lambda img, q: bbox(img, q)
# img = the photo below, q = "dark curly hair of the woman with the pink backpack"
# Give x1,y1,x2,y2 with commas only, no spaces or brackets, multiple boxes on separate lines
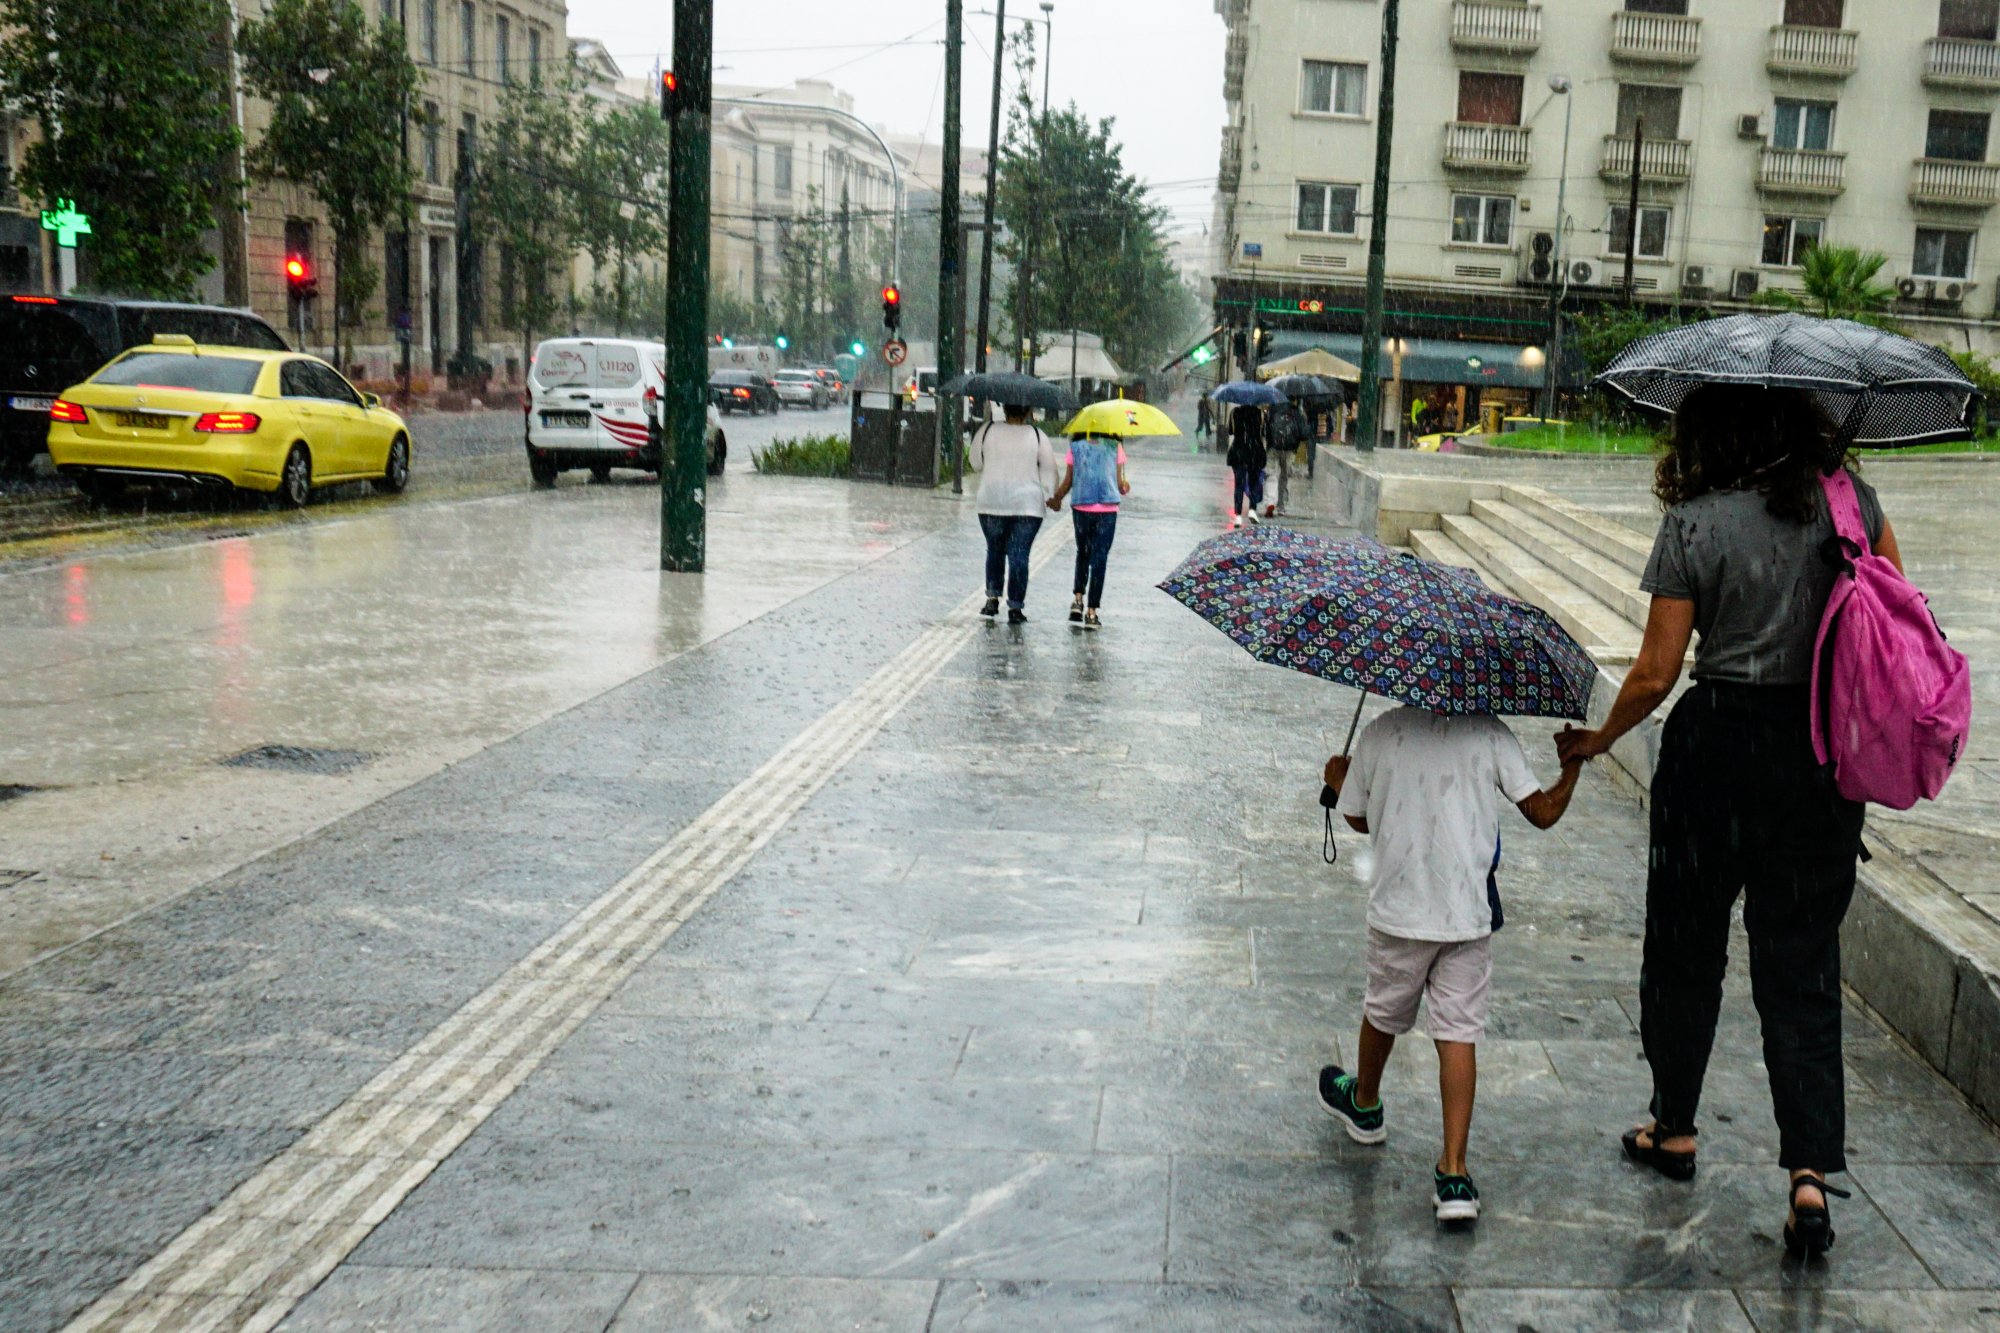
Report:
1652,384,1850,522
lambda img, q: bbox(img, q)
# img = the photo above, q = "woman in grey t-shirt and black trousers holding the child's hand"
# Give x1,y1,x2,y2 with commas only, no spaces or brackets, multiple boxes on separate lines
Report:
1558,384,1902,1255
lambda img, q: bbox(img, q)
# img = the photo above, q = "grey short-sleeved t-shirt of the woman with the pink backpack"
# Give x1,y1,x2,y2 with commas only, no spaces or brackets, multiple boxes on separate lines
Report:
1640,476,1882,685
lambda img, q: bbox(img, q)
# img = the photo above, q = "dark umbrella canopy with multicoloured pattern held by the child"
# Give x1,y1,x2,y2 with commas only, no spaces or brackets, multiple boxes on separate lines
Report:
1160,536,1596,719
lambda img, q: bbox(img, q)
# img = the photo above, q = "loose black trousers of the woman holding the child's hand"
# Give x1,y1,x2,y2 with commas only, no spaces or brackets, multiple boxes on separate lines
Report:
1638,685,1862,1171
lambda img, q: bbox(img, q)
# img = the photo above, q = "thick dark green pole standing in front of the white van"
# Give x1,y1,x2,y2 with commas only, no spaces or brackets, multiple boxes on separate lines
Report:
660,0,716,574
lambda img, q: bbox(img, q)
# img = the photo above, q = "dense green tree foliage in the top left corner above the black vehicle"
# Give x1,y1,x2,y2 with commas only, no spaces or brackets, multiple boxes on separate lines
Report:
0,0,242,298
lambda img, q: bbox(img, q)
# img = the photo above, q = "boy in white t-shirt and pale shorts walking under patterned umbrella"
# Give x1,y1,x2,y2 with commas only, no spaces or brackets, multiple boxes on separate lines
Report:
1320,707,1582,1223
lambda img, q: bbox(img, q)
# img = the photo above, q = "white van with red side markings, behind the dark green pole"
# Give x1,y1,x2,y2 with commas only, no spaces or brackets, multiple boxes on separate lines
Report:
526,338,728,486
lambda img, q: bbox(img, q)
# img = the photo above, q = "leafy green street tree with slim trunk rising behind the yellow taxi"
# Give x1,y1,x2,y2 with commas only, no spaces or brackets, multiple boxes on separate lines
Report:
238,0,418,364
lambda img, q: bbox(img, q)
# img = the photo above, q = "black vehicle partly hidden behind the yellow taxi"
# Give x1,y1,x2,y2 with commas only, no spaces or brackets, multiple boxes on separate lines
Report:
0,296,286,476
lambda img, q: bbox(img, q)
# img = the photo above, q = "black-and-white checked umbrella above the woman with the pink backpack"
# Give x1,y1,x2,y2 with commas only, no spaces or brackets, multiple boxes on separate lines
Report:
1592,314,1980,448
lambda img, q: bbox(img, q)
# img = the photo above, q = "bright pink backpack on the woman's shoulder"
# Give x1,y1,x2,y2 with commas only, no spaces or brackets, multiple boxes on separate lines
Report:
1812,468,1972,811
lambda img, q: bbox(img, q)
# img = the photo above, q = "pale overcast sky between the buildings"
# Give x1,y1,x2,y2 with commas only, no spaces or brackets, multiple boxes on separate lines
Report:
570,0,1224,226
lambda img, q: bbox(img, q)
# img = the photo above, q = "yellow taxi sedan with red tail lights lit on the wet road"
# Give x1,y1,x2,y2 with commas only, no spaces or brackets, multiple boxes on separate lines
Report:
48,334,410,508
